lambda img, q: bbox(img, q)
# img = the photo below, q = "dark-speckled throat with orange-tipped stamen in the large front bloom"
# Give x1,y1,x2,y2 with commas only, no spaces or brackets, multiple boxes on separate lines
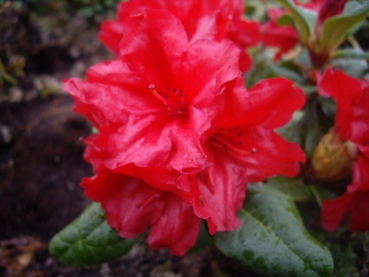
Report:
149,84,188,116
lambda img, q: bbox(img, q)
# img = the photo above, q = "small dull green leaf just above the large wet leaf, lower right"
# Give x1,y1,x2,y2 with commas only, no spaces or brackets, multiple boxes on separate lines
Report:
267,175,311,201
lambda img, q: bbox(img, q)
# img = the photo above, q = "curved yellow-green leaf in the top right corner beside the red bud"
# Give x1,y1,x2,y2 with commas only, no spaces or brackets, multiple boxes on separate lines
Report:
320,1,369,52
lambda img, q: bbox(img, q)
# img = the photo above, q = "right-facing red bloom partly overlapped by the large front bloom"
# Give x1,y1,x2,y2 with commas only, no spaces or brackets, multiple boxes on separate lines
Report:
102,75,305,234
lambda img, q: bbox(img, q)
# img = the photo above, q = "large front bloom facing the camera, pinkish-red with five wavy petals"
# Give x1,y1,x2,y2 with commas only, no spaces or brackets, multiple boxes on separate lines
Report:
64,10,240,171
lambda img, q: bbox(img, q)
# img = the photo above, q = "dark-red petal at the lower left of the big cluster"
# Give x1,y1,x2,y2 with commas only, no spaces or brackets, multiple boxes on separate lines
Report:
81,173,165,238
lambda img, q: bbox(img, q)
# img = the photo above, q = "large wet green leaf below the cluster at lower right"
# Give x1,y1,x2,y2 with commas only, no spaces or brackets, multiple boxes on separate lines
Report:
215,186,333,277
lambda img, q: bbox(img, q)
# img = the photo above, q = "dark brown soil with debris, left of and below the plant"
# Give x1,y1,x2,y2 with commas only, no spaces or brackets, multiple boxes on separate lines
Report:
0,0,369,277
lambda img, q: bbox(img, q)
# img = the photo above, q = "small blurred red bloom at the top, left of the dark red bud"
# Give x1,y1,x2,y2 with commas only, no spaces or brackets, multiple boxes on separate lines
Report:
261,8,299,60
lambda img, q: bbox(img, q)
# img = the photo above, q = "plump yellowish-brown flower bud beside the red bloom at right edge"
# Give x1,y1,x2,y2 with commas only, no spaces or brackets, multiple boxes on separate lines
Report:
311,129,358,181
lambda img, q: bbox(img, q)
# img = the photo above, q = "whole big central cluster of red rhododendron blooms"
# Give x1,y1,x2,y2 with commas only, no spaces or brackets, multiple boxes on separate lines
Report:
64,0,305,255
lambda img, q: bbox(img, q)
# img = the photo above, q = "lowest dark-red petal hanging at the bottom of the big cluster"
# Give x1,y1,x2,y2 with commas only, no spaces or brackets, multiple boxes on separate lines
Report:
148,193,200,256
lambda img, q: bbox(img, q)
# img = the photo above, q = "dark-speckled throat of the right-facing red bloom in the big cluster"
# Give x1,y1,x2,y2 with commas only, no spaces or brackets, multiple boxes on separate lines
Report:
210,126,257,156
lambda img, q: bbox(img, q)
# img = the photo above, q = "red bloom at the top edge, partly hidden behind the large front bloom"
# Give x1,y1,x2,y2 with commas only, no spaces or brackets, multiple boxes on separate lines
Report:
99,0,260,71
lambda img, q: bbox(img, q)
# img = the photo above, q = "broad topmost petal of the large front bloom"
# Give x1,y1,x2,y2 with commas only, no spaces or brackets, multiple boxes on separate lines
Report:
120,10,188,88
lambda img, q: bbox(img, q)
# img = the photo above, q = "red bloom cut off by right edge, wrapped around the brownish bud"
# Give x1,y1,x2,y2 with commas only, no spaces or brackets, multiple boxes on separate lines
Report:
318,69,369,231
